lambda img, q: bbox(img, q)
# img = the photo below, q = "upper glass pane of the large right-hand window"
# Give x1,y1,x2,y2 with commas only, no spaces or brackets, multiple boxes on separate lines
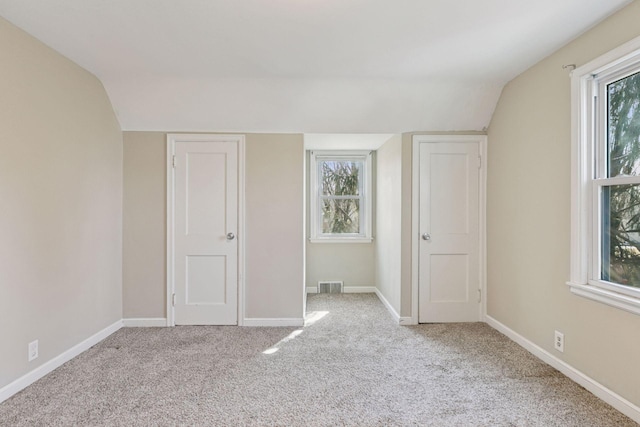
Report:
607,73,640,177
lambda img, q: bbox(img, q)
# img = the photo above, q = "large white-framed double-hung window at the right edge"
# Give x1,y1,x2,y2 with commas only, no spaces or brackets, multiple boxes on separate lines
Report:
569,38,640,314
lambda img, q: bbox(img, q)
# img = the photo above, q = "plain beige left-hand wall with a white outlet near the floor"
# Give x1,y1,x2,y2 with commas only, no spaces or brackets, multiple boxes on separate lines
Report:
0,18,122,388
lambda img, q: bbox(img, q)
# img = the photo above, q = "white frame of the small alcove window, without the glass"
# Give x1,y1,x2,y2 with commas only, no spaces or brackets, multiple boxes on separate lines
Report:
309,150,373,243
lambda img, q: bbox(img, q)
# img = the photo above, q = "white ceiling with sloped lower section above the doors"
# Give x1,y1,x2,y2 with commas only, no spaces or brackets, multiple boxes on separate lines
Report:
0,0,631,133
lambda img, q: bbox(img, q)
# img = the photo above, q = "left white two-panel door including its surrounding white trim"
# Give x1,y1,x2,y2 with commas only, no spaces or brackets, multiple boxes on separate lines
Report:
169,135,238,325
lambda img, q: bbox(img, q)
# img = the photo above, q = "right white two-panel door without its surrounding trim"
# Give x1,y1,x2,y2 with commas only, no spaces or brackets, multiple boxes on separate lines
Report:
418,142,480,323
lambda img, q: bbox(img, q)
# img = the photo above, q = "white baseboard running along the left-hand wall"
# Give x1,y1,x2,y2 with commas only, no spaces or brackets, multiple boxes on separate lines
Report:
0,320,122,403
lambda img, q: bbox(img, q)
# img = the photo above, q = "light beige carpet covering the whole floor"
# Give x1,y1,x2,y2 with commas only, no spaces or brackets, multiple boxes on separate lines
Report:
0,294,636,427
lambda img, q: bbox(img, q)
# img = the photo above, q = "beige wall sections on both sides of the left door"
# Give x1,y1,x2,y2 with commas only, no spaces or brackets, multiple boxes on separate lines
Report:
123,132,304,319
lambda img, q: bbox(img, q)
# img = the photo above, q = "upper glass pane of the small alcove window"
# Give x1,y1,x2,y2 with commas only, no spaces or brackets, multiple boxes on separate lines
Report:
319,160,363,196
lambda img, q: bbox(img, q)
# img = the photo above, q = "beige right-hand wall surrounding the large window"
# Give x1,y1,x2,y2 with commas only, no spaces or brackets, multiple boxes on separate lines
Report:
487,2,640,405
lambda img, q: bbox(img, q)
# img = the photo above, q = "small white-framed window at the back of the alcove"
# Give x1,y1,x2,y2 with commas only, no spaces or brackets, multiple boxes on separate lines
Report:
310,151,371,242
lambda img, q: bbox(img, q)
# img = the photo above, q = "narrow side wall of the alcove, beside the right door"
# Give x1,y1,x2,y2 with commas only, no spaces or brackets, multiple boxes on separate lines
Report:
375,135,402,313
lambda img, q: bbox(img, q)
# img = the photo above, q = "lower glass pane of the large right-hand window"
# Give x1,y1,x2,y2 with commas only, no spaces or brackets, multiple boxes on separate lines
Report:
601,184,640,287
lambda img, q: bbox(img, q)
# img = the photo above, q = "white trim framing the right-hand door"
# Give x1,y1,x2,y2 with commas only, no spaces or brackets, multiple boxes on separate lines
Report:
410,135,488,325
